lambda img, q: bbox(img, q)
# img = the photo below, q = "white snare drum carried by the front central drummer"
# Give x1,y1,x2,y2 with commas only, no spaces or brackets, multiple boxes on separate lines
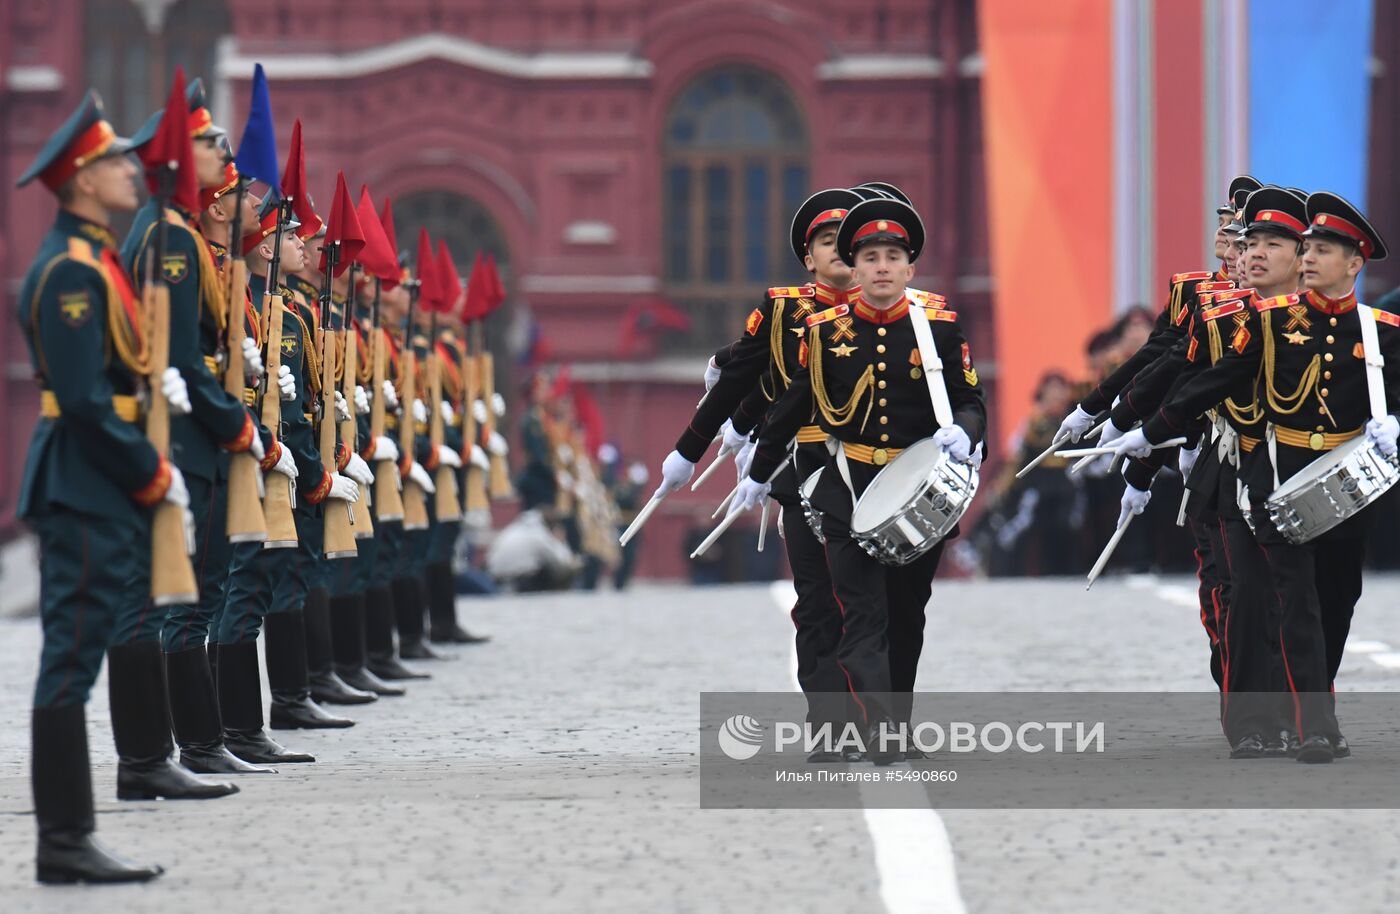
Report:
851,438,977,565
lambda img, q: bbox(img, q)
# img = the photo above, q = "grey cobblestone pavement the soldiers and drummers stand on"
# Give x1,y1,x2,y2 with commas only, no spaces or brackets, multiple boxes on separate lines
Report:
0,578,1400,914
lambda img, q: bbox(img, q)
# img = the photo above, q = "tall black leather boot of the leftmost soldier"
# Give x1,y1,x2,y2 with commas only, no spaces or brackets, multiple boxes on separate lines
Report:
29,704,165,885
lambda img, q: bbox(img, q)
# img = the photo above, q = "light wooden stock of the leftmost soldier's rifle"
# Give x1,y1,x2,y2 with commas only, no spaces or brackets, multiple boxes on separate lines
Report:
143,283,199,606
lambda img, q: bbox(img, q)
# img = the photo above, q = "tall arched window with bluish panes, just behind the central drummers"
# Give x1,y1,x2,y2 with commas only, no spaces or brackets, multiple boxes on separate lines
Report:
662,66,808,349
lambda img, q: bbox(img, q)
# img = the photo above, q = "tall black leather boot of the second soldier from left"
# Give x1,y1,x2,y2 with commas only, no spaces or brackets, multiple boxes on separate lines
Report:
106,641,238,799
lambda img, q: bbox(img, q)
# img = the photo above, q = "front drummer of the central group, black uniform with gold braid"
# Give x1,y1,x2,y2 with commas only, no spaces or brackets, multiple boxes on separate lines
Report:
732,199,987,764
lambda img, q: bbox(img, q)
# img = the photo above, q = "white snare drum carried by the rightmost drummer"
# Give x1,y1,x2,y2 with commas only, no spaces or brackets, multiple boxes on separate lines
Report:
1266,435,1400,543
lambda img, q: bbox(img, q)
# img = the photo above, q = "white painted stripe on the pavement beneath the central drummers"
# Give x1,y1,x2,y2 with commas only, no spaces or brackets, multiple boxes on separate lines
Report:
769,581,966,914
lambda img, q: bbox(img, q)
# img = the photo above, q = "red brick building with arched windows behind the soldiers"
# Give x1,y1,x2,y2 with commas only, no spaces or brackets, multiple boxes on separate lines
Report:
0,0,994,575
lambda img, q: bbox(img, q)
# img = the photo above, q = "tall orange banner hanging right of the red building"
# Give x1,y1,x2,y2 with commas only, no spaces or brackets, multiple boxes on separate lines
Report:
977,0,1113,448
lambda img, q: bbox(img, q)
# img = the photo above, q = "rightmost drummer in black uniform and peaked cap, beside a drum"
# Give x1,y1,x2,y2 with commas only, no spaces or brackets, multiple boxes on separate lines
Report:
1116,193,1400,763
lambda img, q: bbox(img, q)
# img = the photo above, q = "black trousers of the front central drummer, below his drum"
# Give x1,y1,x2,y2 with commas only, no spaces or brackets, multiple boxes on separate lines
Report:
822,515,944,726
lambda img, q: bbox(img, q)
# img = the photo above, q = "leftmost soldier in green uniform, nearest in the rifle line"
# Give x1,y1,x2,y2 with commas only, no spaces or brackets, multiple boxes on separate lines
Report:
18,92,189,883
